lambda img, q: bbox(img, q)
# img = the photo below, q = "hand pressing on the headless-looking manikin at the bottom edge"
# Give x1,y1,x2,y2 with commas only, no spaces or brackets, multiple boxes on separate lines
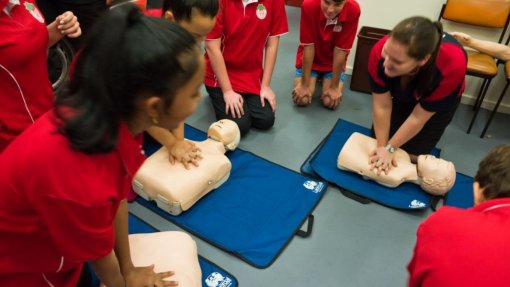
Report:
125,265,179,287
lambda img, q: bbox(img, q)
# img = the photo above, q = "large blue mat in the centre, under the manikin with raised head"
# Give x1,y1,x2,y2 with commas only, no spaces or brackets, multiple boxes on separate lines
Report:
137,126,327,268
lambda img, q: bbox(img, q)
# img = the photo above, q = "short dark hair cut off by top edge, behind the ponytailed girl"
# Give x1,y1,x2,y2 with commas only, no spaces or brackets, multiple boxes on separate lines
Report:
163,0,219,22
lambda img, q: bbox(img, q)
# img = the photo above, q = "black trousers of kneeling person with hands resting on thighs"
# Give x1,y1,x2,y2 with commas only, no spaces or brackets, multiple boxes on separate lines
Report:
205,86,275,135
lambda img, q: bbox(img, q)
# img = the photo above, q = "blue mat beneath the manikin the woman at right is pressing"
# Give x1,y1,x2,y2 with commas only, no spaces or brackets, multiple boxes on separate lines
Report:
302,119,439,210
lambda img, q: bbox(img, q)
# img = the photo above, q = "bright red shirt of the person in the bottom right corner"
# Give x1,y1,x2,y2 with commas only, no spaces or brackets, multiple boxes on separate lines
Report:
407,198,510,287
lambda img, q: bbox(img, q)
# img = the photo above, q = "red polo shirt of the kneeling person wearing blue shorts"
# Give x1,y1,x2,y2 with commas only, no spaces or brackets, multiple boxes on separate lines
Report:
296,0,361,72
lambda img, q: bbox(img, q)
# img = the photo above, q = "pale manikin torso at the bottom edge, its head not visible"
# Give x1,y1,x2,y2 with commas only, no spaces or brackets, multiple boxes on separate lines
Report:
101,231,202,287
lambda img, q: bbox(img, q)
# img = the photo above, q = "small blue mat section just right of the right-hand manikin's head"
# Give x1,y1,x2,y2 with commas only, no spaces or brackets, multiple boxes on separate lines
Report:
444,173,474,208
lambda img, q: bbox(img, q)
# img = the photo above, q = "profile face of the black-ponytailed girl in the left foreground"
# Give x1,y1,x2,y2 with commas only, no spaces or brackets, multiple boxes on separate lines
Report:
158,56,205,130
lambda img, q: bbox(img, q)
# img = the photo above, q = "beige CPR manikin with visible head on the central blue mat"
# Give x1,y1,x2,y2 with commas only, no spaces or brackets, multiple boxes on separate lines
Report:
133,119,241,215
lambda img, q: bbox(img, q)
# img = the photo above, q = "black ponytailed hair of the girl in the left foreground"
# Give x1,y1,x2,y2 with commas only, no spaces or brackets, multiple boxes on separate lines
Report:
55,4,199,153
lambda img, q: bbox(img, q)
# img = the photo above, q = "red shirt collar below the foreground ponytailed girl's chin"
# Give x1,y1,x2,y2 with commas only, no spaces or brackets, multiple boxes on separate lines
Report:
115,123,145,180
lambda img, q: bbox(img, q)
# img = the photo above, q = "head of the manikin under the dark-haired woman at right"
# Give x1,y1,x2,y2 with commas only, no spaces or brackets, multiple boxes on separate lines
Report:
417,155,456,195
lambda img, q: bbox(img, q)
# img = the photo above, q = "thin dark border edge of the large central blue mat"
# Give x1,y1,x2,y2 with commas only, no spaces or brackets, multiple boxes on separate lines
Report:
136,124,329,269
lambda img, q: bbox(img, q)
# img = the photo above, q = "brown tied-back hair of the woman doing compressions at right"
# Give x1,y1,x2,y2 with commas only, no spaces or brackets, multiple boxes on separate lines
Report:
390,16,443,98
